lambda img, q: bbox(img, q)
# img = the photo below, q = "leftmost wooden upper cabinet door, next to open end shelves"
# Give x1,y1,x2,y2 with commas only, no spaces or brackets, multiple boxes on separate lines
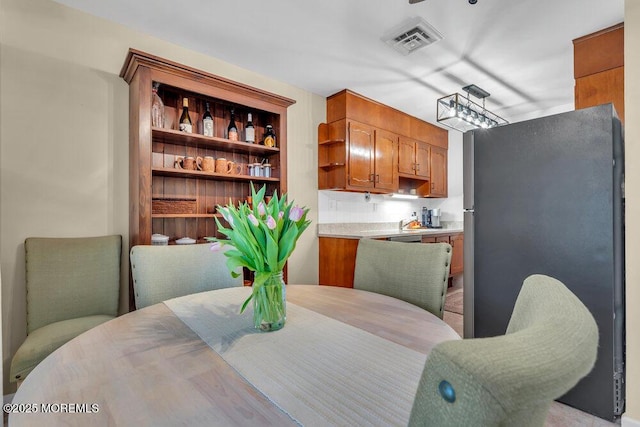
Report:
348,121,374,189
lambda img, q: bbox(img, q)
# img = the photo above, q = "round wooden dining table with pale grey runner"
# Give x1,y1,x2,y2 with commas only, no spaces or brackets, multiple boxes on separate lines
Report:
4,285,460,426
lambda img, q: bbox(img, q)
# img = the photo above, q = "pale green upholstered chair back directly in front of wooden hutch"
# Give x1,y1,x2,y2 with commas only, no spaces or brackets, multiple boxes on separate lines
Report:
130,244,243,309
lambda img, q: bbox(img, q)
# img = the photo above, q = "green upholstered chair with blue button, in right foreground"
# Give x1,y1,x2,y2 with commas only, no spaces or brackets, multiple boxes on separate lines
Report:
409,275,598,427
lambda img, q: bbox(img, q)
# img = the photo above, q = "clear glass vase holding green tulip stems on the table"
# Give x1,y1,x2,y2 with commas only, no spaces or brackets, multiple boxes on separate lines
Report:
253,271,287,332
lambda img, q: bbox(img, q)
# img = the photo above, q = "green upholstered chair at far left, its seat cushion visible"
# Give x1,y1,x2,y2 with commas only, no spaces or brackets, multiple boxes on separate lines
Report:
9,235,122,384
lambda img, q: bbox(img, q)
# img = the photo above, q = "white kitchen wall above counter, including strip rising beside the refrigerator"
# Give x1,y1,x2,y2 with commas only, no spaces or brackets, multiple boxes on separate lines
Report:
318,131,462,224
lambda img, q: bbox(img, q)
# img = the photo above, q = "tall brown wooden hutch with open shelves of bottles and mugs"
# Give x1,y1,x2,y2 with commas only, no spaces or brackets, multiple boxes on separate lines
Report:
120,49,295,308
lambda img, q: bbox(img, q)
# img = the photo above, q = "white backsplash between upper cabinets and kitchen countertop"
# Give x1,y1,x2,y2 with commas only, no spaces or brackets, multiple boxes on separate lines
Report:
318,190,463,223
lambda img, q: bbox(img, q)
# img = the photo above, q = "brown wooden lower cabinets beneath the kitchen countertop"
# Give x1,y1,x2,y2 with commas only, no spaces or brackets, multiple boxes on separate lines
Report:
319,233,464,288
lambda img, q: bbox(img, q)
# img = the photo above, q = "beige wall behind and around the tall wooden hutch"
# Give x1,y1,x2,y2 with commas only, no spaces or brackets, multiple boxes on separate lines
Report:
0,0,325,393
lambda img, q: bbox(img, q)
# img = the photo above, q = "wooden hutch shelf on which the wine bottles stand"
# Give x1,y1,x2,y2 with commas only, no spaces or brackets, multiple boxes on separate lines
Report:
151,127,280,157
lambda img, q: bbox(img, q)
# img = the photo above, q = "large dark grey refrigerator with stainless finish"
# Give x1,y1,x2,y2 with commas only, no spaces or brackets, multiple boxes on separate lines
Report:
463,104,625,420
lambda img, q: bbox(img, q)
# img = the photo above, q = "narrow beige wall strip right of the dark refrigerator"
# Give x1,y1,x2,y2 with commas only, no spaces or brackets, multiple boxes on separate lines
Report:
623,0,640,426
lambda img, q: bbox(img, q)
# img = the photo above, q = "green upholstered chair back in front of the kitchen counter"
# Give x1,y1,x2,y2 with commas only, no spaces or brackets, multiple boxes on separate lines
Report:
353,239,451,319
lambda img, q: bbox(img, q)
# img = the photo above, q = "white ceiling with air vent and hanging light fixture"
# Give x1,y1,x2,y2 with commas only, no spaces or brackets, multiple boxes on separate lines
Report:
52,0,624,127
